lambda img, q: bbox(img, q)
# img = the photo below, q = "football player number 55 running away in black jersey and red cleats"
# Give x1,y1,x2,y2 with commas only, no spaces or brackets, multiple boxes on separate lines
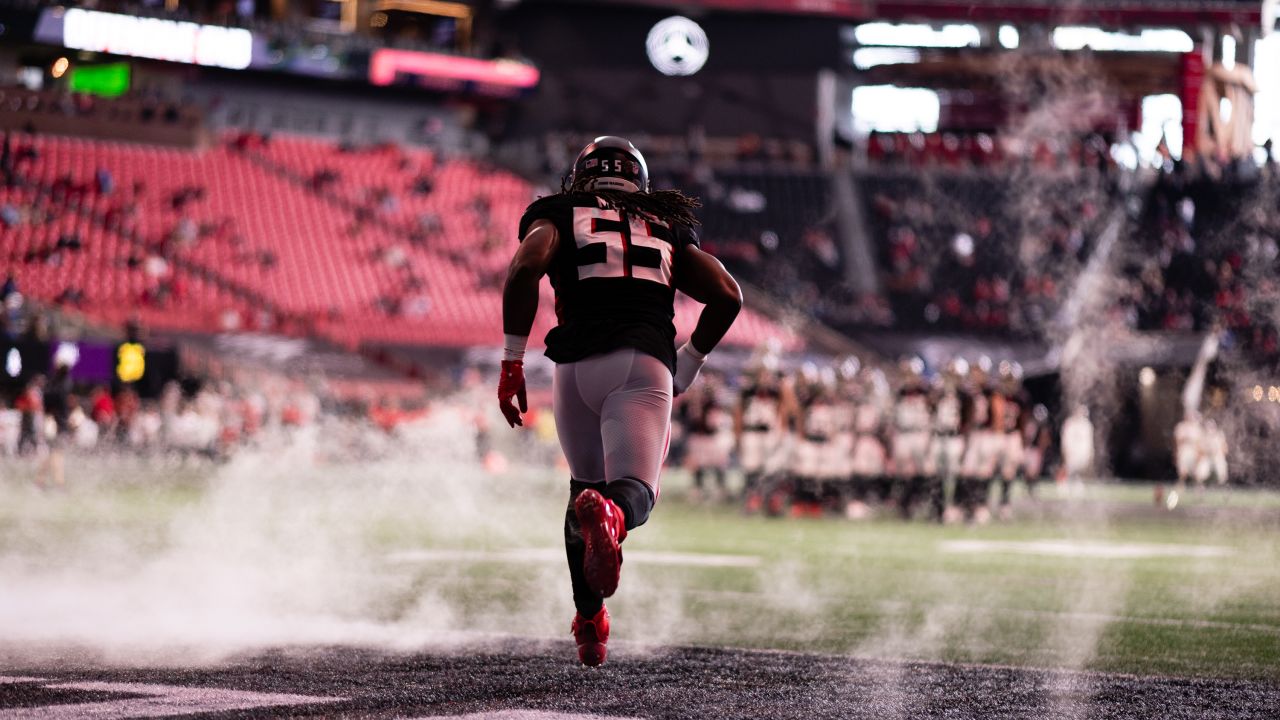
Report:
498,136,742,666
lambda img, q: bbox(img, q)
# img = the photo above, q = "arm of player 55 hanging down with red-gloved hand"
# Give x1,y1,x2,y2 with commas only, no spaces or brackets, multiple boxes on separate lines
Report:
498,215,559,428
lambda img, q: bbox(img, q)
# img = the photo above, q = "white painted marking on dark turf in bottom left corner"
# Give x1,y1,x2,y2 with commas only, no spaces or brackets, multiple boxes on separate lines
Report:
0,676,347,720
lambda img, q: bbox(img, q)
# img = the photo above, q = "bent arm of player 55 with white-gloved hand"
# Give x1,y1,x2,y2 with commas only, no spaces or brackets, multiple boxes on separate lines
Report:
672,243,742,395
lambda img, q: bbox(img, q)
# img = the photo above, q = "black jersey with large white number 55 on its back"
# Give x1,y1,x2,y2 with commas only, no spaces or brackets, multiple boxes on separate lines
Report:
520,192,698,373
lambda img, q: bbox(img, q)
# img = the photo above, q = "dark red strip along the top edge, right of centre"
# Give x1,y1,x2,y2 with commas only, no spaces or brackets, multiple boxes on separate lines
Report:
532,0,1262,28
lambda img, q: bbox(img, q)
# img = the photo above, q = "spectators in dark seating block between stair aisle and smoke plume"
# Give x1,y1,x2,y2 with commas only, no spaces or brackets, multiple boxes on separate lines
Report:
863,155,1115,337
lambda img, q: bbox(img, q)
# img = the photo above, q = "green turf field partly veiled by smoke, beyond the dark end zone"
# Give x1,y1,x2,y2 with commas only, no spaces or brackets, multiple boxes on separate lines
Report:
0,454,1280,680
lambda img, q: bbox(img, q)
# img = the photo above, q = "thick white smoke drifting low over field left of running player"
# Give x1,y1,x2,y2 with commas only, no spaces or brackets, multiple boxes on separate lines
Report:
0,413,570,664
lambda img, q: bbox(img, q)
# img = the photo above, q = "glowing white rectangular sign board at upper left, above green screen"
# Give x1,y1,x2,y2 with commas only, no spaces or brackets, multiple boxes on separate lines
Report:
63,8,253,70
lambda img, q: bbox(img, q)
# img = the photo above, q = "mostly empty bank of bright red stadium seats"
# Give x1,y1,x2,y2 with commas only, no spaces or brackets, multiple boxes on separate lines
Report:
5,133,799,347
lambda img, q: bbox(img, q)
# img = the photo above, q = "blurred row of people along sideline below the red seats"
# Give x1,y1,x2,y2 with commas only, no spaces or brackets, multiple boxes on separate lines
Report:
0,351,499,487
